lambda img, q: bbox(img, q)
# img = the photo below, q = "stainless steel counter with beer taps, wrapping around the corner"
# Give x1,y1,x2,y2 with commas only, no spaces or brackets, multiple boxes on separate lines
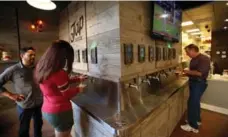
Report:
72,78,188,133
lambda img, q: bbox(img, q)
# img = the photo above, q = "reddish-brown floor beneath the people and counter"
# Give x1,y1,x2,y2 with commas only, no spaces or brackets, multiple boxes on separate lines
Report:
0,108,228,137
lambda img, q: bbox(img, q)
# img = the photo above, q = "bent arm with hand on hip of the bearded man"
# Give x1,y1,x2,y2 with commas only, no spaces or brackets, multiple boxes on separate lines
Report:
0,67,24,101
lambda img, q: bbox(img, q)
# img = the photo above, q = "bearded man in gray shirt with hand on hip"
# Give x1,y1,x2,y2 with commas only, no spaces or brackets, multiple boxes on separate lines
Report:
0,47,43,137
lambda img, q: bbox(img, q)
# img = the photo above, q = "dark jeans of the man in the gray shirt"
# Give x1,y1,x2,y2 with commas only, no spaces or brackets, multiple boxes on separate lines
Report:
17,106,43,137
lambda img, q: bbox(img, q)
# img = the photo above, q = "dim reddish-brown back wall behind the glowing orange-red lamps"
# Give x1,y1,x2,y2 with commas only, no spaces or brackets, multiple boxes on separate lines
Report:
19,3,59,59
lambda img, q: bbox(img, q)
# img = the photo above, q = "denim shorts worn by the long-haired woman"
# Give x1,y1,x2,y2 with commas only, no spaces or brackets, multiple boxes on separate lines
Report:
42,110,74,132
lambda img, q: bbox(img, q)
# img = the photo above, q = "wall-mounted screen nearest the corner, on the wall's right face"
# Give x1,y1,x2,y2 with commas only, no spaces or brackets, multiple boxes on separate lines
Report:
124,44,133,65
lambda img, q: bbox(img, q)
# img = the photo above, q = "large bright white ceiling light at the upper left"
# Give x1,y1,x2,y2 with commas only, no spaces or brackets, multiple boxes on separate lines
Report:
26,0,56,10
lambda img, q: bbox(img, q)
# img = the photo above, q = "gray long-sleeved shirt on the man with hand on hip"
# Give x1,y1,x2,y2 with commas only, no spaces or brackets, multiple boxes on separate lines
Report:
0,63,43,108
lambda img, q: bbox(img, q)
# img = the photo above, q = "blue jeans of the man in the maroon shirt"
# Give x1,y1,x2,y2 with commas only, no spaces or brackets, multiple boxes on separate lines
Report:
188,79,207,129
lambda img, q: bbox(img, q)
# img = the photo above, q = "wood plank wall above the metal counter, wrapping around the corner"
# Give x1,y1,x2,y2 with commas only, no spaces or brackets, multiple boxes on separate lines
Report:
59,1,181,81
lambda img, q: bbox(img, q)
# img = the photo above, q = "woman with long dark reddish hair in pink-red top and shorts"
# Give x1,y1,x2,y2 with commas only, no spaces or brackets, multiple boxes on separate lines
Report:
35,40,83,137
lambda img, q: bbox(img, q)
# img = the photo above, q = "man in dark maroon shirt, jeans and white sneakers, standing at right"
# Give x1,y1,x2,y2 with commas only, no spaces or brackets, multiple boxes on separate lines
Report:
181,44,210,133
